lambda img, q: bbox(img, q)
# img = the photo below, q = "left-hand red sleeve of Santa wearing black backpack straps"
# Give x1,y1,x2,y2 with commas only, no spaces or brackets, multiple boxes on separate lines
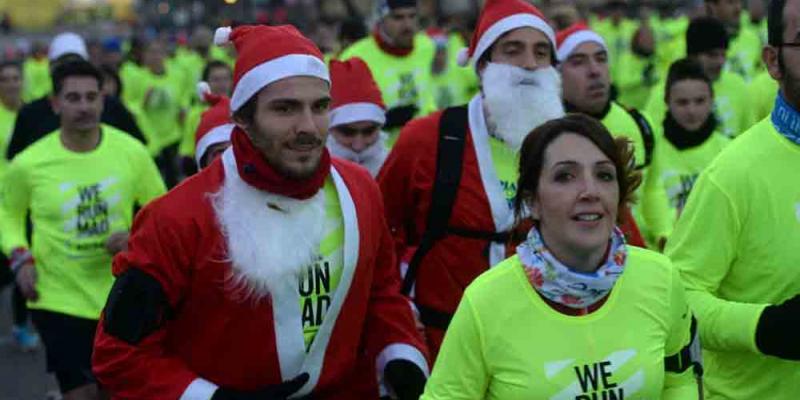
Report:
377,113,440,274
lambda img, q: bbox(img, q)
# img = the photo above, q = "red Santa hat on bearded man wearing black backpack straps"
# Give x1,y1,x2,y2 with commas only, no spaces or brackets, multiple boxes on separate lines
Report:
458,0,556,67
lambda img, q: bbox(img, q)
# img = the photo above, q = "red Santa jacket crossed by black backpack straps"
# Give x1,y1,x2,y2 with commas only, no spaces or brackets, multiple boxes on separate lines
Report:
378,96,528,357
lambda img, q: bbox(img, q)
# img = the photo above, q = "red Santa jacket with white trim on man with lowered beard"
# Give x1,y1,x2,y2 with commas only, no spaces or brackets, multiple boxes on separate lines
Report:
93,150,427,399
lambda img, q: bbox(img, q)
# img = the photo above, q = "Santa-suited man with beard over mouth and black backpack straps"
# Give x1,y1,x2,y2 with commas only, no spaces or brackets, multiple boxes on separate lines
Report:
378,0,564,355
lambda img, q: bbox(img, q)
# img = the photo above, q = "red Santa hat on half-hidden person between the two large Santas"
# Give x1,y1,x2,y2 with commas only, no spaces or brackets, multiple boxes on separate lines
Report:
329,57,386,128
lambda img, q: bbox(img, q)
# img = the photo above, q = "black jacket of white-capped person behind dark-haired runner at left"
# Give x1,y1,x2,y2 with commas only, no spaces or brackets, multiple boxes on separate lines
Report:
6,96,145,160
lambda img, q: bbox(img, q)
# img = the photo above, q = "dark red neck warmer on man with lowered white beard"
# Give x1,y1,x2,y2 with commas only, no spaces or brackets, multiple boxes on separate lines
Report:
231,127,331,200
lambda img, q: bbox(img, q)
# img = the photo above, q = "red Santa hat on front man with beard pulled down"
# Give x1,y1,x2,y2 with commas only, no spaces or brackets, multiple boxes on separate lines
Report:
214,25,330,112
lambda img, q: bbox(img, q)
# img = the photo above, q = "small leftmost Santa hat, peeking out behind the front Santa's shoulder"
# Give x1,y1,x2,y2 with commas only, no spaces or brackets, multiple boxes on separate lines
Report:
194,82,235,167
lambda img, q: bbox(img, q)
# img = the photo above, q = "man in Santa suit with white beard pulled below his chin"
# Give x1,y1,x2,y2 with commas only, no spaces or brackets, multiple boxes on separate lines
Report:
93,26,428,400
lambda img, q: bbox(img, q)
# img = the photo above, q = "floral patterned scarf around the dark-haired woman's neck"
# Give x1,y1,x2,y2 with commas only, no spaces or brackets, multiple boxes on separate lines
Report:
517,227,628,309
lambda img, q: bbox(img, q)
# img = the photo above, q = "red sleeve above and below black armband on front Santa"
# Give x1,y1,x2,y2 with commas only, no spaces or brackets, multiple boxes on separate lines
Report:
92,200,197,399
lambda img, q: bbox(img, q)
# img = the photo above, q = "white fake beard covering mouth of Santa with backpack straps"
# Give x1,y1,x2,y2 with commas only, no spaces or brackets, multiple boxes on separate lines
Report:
481,63,565,151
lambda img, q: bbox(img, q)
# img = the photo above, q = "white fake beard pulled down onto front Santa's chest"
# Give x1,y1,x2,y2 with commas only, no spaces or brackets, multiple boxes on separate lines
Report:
211,176,326,300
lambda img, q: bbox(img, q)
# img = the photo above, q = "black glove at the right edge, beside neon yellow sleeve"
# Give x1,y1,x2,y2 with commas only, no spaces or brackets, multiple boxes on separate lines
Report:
756,295,800,361
